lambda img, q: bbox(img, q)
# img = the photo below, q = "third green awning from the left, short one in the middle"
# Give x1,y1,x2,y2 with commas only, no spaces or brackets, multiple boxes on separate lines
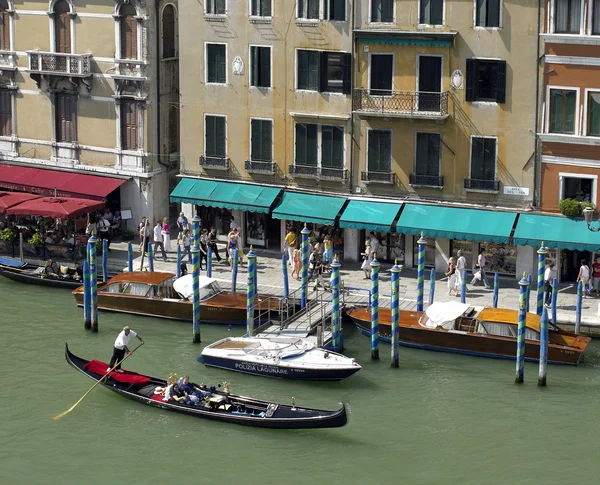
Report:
340,200,402,232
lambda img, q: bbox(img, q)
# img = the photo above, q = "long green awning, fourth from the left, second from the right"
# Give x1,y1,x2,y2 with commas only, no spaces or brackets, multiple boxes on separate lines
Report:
396,204,517,243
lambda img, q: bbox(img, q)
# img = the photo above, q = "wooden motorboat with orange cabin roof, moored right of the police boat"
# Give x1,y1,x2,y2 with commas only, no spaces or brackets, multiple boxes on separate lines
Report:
346,302,591,365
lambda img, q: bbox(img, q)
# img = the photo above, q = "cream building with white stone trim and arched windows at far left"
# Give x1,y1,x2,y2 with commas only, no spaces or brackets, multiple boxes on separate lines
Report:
0,0,179,229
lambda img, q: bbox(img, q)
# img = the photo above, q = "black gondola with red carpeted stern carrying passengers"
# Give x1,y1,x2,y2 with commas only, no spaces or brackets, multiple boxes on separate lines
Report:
65,344,348,429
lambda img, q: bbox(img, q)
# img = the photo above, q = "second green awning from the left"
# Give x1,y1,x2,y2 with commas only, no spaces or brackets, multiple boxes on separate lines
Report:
271,192,346,224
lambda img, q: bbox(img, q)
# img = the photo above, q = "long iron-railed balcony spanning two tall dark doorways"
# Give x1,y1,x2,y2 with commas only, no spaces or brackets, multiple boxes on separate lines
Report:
352,89,449,121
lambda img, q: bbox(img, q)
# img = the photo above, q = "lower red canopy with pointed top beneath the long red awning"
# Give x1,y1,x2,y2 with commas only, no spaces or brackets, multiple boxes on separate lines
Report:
6,197,104,219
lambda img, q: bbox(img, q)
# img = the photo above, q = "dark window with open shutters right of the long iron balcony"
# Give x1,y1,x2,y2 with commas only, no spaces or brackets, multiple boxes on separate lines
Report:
466,59,506,103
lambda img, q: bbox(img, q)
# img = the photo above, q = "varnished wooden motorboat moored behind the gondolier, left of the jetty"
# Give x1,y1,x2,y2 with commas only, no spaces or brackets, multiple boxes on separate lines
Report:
73,271,280,325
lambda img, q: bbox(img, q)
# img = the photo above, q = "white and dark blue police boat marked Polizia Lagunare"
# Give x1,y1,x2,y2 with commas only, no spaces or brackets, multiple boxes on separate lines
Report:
198,337,361,381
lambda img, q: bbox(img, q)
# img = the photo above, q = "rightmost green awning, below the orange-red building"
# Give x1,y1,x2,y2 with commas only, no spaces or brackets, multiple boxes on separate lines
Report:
513,214,600,251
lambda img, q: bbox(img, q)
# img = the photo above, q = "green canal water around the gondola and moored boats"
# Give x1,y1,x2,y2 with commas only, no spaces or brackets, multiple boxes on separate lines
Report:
0,280,600,485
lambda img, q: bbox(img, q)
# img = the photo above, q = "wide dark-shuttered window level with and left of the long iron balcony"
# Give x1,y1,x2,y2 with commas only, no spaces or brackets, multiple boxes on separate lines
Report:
297,50,351,94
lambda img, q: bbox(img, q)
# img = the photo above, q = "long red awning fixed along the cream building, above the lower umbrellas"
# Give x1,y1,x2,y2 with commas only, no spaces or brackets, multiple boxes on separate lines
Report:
0,163,127,200
